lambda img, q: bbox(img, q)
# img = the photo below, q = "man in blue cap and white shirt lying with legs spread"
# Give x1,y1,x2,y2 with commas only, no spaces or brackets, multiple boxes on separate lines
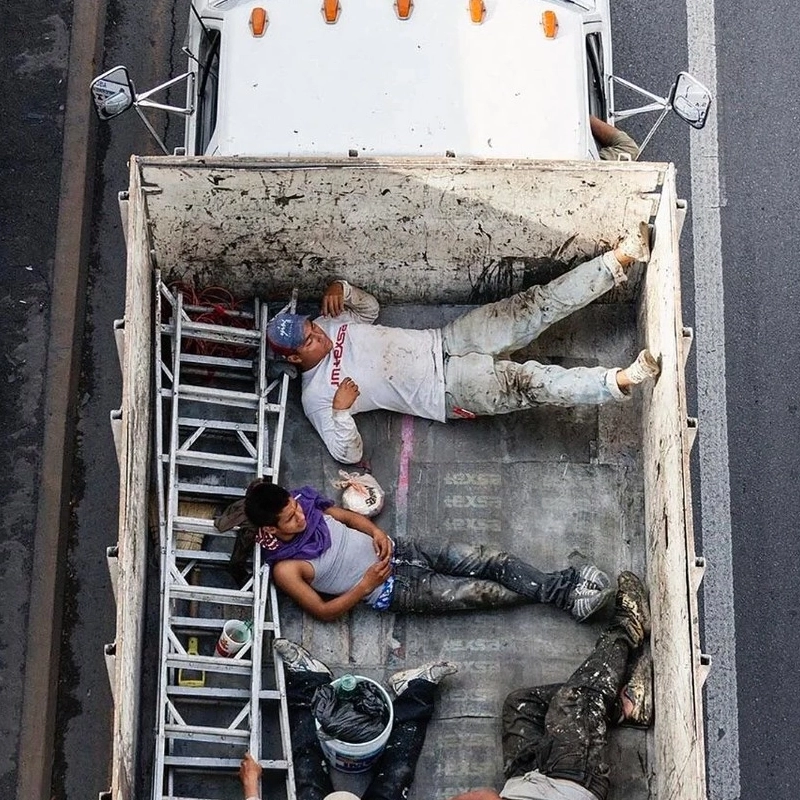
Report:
267,223,660,464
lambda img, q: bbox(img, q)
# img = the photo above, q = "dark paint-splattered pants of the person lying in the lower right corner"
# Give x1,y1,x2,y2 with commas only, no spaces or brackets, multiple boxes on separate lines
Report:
503,631,629,800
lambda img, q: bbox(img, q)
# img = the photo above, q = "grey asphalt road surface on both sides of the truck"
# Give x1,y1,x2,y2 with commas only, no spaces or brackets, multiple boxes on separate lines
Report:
0,0,800,800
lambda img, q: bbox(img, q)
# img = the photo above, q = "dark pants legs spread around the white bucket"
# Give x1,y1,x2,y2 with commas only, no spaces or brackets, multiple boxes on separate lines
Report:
286,670,436,800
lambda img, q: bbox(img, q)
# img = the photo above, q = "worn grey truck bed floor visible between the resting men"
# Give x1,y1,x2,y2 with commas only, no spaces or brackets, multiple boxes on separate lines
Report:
281,304,652,800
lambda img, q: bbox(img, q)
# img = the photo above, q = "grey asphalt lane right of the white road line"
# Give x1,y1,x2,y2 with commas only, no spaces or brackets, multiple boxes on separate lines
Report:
712,0,800,800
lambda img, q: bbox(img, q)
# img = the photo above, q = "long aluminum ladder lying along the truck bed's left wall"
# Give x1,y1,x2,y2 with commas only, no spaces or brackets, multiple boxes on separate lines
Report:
152,282,296,800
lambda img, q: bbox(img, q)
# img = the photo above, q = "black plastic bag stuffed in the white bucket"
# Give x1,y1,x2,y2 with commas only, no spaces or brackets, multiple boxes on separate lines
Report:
311,681,389,744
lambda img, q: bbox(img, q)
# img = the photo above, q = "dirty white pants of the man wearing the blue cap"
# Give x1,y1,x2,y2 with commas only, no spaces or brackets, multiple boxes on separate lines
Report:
442,253,627,418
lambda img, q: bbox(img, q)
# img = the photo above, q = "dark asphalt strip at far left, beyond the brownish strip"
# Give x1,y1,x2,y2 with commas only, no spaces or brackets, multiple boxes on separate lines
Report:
0,0,69,797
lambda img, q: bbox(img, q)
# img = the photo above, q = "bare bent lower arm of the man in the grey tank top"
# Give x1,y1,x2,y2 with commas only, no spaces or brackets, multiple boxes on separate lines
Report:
272,558,391,622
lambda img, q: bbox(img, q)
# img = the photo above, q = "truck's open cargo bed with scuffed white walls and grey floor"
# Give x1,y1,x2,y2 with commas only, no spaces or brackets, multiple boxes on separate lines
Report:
111,158,708,800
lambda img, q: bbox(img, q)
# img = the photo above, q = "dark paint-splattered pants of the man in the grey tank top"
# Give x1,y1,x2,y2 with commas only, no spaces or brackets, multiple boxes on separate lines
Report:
389,539,578,613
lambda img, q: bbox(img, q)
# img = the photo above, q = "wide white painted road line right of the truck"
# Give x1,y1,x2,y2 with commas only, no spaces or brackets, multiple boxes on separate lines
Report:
686,0,741,800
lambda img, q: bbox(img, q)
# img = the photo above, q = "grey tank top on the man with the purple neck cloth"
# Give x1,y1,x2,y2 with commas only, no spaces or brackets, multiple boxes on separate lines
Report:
307,514,383,603
